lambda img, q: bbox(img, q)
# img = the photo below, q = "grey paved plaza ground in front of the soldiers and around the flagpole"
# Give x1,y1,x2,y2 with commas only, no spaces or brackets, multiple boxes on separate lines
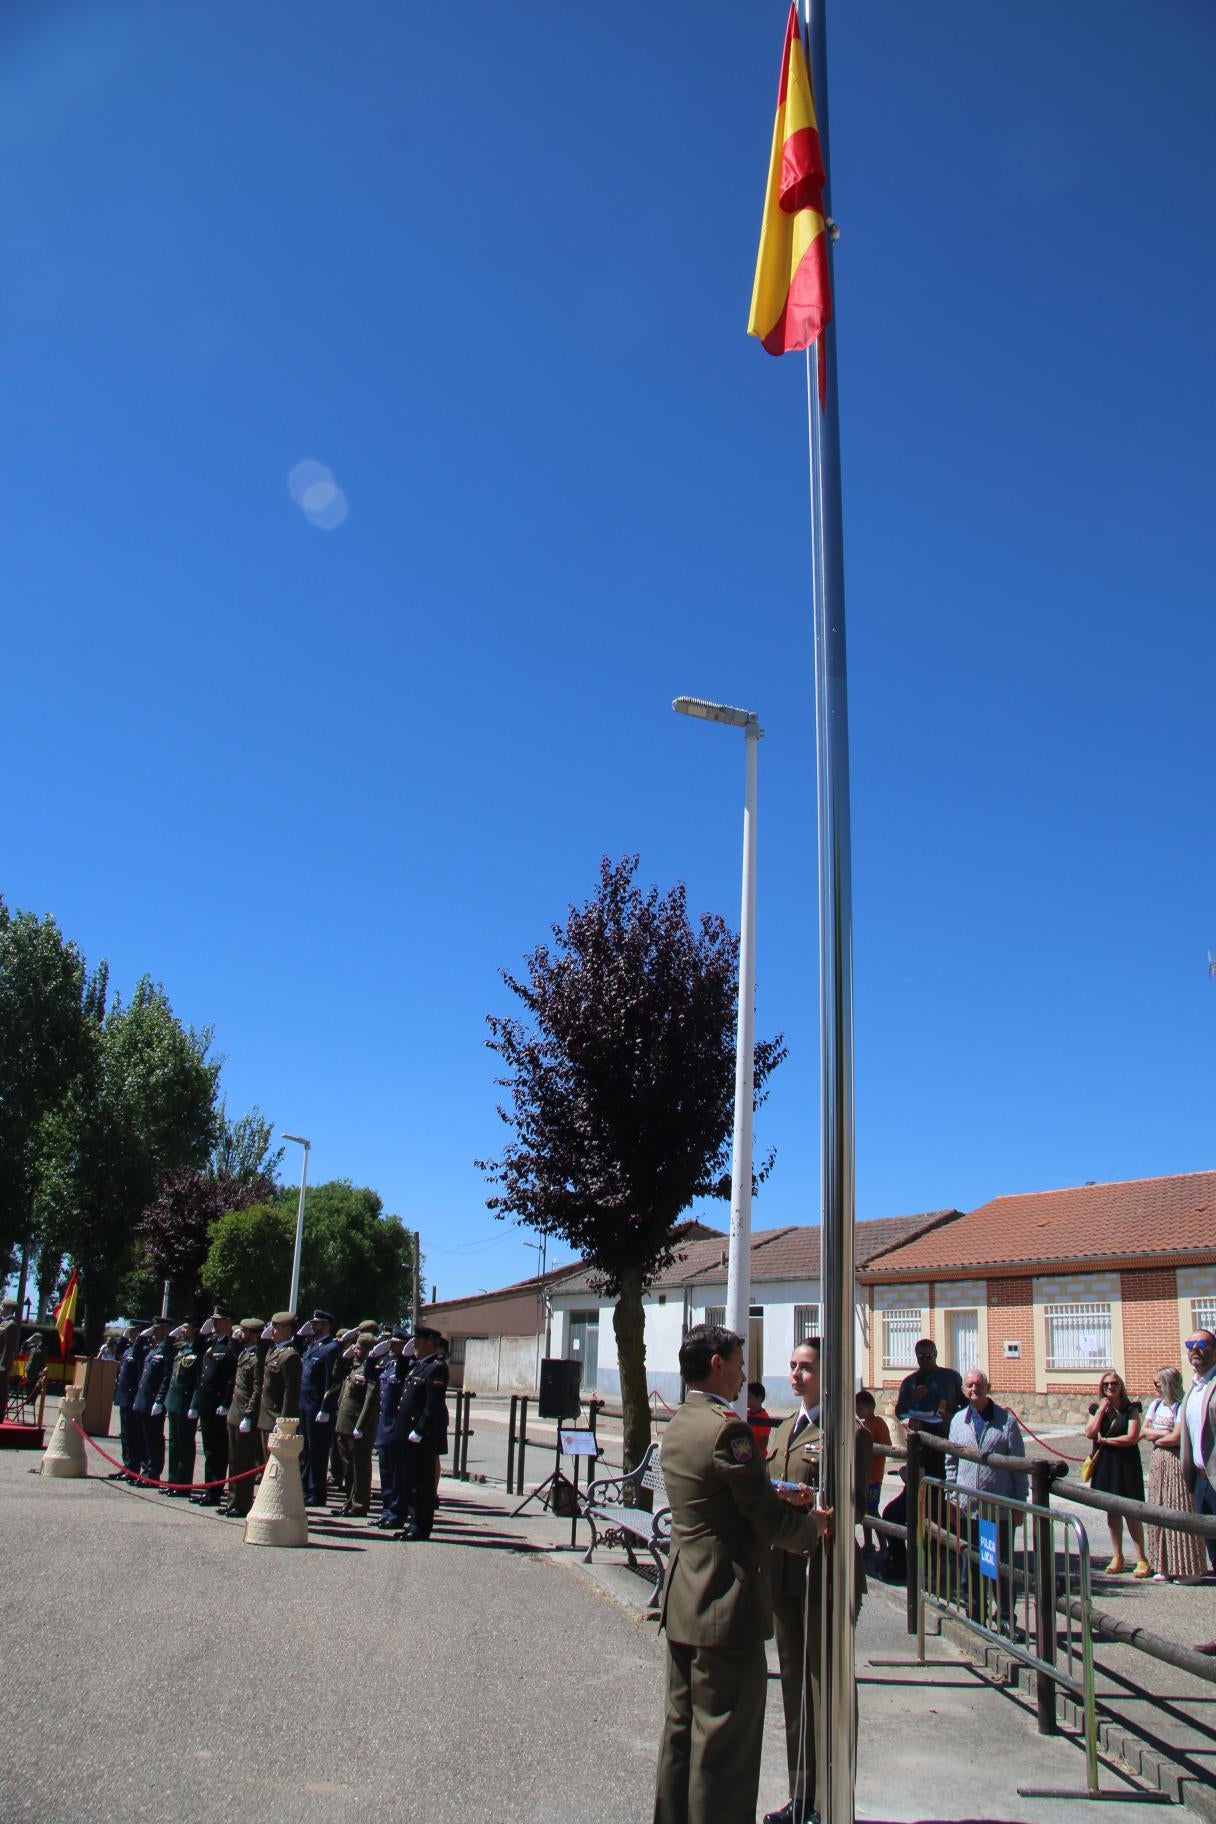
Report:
0,1430,1210,1824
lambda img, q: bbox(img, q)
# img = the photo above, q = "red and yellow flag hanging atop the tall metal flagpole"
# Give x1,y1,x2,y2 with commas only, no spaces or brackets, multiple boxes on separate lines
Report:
747,5,831,405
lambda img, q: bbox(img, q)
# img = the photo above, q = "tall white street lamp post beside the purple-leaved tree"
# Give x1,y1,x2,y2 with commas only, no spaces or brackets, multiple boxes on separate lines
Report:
671,697,764,1414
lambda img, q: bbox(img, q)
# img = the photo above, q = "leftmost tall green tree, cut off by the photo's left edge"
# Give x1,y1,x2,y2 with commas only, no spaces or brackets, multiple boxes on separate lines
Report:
0,897,106,1268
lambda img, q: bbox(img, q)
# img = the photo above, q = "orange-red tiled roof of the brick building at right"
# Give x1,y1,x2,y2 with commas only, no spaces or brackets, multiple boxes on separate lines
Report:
866,1171,1216,1279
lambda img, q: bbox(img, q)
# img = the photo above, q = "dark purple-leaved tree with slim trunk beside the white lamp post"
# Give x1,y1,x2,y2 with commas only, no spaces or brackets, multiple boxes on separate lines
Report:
478,855,786,1465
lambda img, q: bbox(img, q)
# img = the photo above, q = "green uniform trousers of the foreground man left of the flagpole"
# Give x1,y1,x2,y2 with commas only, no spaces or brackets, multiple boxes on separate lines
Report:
654,1640,768,1824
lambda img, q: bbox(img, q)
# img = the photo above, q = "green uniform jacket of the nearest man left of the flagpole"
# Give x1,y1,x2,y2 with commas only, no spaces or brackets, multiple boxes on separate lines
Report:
660,1392,817,1647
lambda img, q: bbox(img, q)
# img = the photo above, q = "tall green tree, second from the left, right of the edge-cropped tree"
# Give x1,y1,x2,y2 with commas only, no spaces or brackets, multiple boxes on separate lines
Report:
36,978,219,1348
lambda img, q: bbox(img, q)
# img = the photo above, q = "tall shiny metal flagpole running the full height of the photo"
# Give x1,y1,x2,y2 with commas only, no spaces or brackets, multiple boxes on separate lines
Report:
804,0,857,1824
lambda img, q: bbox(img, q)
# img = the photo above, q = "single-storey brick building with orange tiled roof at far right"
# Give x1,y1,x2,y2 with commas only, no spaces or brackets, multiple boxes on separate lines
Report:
857,1171,1216,1421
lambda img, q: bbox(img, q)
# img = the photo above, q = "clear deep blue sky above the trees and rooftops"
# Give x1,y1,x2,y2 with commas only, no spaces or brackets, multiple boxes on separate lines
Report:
0,0,1216,1297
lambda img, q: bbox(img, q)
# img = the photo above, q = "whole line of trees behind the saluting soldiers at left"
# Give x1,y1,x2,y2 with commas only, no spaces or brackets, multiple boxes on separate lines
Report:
0,897,414,1348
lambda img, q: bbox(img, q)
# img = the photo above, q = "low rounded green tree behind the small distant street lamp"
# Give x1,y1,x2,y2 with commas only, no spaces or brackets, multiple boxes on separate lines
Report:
202,1178,414,1322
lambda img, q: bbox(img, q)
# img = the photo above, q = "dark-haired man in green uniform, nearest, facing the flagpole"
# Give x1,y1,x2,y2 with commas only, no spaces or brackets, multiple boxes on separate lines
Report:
654,1324,831,1824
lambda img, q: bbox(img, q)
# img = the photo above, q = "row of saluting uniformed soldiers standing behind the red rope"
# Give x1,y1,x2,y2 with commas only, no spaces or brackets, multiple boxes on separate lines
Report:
115,1304,448,1539
